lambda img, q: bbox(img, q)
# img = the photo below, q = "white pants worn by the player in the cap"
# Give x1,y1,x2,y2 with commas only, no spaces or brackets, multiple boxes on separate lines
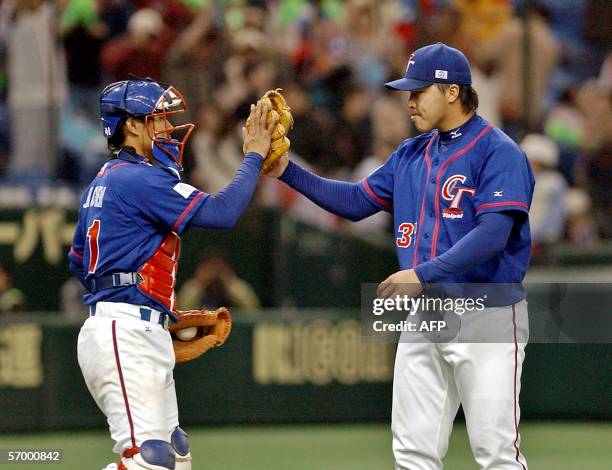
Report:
391,300,529,470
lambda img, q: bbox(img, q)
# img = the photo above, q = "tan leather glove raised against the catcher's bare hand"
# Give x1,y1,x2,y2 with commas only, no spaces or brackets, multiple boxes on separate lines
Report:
246,88,293,175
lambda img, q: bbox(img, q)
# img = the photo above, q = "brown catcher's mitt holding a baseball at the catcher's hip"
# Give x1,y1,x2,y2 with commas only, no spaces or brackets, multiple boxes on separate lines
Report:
168,307,232,362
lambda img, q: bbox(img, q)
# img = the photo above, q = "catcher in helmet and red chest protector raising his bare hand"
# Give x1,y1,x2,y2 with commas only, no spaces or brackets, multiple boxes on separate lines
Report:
68,77,274,470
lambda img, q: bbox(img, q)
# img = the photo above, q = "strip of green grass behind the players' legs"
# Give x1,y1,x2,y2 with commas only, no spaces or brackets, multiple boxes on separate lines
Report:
0,423,612,470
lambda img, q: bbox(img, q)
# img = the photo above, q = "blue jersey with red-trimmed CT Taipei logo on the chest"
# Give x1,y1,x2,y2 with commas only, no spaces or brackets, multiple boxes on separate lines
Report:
360,115,535,303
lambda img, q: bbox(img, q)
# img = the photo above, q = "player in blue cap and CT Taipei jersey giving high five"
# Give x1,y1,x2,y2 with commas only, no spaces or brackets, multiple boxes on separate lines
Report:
268,43,534,470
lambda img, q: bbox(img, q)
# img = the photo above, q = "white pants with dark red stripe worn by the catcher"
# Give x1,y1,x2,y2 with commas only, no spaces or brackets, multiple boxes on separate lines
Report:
78,302,179,454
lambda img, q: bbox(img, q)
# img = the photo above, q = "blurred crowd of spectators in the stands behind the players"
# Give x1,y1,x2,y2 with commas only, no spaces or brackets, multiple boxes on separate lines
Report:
0,0,612,258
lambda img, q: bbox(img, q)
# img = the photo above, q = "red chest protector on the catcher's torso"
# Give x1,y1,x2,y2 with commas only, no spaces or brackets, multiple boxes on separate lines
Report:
138,232,181,311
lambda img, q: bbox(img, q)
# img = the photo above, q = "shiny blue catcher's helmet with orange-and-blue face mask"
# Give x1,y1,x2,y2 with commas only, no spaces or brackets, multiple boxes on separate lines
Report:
100,77,194,166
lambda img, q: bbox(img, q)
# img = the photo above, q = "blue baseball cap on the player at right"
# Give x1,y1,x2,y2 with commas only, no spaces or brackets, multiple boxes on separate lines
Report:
385,42,472,91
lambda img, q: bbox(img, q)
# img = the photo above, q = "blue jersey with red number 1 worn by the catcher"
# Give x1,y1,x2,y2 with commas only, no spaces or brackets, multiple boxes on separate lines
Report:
68,150,209,313
